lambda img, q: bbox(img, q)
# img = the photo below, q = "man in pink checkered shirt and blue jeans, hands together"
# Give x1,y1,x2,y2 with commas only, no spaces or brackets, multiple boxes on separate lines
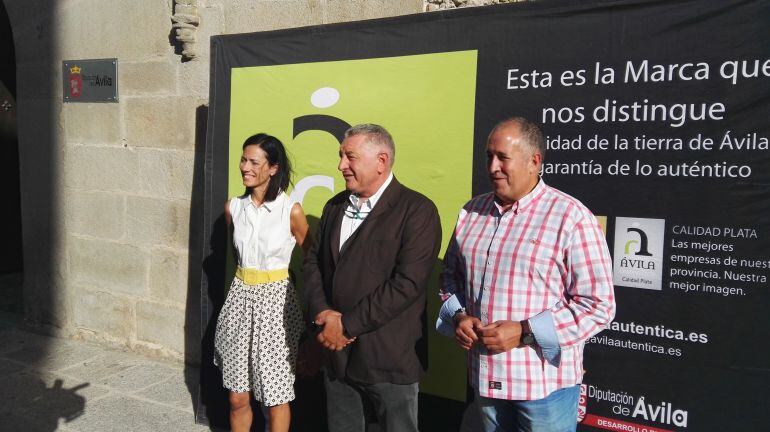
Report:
436,117,615,432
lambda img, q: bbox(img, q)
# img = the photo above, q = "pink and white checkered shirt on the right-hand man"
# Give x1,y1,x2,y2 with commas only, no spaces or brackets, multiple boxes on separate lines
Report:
441,180,615,400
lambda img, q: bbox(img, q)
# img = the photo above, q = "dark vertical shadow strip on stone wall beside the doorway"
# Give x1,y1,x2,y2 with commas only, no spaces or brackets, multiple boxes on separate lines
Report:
0,2,56,330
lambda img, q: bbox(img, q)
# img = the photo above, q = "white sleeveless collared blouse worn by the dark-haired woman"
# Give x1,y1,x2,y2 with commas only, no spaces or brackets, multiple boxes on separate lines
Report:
230,192,296,271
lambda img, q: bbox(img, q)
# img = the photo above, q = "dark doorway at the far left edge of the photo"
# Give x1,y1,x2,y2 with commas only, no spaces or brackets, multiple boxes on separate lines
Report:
0,2,24,313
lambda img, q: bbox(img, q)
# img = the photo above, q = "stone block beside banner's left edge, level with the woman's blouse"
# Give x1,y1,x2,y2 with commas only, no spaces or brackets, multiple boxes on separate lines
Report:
126,197,190,248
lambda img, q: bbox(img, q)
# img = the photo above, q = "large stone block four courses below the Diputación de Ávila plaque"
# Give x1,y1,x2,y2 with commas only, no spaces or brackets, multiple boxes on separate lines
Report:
69,237,147,296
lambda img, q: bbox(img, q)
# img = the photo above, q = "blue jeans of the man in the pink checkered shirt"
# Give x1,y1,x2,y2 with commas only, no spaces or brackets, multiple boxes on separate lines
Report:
476,385,580,432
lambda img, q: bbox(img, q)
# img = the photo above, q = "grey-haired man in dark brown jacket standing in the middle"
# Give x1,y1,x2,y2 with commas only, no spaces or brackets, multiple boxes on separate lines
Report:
304,124,441,432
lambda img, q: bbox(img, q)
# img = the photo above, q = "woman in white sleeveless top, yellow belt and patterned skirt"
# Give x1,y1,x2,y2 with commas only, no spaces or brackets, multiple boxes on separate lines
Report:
214,134,309,432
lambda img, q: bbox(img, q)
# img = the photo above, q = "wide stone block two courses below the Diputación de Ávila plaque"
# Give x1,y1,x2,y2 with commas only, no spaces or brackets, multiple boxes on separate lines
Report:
62,146,140,192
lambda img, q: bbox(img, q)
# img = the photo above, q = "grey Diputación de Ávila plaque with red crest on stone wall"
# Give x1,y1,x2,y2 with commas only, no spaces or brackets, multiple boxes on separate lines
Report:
62,58,118,102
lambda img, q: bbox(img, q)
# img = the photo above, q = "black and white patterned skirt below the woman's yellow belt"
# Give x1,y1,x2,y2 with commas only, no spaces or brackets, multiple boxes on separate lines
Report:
214,277,303,406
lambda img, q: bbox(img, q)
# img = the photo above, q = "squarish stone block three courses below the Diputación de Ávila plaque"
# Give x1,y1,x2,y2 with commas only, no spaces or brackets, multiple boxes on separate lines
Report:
64,189,126,240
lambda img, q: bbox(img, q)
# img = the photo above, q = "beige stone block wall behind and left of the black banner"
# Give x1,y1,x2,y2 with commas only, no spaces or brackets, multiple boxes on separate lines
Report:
3,0,425,362
